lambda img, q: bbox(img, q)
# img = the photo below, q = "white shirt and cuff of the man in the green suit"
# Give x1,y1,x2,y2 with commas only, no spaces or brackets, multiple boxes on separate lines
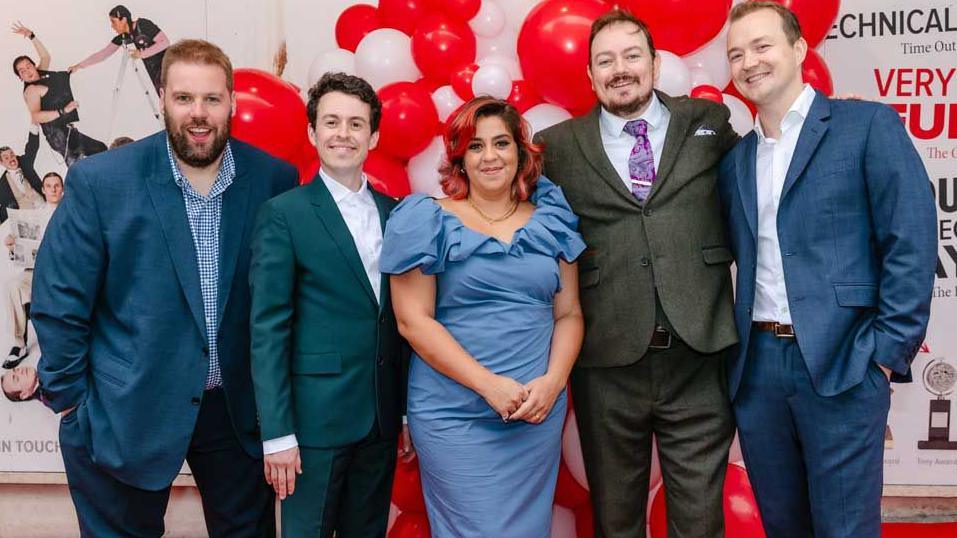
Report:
263,169,382,454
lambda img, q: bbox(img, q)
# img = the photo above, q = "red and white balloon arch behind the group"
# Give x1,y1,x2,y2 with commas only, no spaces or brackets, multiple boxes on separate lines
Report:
222,0,929,538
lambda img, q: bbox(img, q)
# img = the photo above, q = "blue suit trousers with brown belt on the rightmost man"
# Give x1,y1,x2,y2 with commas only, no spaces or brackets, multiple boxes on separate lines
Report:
734,331,890,538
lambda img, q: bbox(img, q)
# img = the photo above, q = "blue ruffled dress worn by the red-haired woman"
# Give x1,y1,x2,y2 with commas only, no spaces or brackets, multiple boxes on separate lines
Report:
379,177,585,538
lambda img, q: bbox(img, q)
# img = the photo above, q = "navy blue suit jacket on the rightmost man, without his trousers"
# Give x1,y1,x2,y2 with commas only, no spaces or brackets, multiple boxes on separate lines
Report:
718,93,937,398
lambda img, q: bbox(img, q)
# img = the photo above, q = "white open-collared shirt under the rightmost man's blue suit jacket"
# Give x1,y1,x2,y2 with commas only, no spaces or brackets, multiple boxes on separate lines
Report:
753,84,815,325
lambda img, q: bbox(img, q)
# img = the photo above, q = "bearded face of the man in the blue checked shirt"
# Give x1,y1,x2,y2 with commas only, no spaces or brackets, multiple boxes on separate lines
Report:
160,62,236,168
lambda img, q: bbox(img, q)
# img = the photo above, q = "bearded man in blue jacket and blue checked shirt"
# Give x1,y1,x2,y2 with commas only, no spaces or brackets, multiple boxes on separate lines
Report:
33,40,295,537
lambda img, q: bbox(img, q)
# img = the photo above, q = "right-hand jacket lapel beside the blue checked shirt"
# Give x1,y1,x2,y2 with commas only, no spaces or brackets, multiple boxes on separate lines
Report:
216,144,252,325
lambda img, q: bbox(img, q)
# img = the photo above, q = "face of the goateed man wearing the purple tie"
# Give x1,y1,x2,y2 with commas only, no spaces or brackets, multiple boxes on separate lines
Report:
588,22,661,118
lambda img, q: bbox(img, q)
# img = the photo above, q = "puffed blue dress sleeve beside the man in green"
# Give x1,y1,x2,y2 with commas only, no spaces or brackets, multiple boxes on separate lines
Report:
379,194,446,275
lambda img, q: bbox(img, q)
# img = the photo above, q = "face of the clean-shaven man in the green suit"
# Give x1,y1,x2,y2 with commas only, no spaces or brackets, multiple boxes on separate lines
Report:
309,92,379,176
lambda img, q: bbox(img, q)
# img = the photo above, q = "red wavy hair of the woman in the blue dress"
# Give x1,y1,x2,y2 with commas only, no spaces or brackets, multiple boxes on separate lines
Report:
439,97,542,201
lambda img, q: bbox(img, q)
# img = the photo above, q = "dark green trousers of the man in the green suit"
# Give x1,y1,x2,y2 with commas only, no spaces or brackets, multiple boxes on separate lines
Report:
281,425,397,538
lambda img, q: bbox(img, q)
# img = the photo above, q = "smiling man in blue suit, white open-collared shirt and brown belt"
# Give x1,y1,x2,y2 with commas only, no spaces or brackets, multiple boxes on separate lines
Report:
719,2,937,538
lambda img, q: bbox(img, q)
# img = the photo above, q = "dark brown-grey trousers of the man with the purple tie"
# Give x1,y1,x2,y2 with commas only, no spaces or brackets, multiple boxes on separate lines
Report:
571,342,734,538
